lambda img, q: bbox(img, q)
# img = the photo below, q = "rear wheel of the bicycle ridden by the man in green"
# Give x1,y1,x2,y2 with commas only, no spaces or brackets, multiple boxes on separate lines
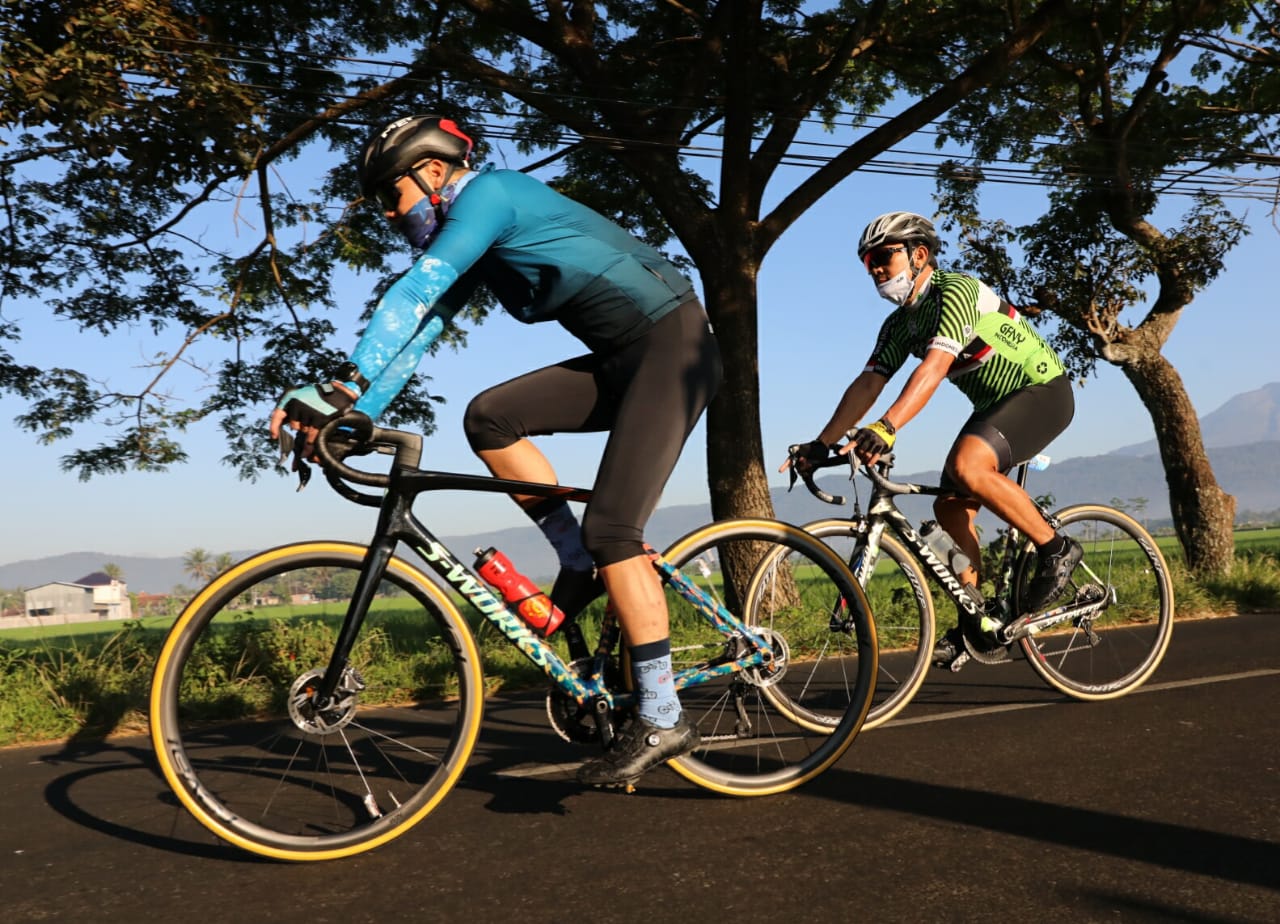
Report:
1014,504,1174,700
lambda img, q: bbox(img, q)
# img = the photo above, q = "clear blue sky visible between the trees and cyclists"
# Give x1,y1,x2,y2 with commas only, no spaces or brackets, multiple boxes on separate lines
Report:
0,149,1280,564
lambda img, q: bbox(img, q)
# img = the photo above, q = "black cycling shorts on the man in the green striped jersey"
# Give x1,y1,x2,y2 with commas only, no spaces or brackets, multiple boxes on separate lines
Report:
942,375,1075,488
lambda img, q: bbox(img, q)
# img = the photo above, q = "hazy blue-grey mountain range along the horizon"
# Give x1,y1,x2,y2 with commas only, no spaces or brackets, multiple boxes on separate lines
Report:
0,383,1280,593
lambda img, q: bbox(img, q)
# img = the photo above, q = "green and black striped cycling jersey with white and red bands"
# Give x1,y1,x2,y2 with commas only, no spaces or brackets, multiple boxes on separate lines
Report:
867,270,1065,411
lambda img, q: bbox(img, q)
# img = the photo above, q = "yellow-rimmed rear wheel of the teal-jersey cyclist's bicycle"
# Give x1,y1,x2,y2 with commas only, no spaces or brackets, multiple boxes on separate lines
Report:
664,520,876,796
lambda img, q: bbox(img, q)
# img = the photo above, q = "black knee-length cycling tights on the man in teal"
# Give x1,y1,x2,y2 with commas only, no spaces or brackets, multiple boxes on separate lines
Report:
463,301,722,566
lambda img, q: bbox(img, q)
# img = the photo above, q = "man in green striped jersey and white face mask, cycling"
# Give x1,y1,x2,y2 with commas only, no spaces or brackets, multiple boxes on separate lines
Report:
782,211,1082,660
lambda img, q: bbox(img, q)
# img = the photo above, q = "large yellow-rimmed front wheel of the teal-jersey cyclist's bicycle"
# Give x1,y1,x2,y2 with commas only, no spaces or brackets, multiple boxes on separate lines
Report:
151,541,484,860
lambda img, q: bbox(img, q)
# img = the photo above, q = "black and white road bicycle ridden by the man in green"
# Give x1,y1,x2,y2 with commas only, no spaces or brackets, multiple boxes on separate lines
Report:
791,447,1174,729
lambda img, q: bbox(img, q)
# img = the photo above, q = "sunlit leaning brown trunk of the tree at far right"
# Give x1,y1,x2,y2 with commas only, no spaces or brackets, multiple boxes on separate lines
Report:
1120,353,1235,575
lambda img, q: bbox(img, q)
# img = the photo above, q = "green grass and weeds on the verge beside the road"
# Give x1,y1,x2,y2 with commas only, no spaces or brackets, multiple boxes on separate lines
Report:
0,530,1280,745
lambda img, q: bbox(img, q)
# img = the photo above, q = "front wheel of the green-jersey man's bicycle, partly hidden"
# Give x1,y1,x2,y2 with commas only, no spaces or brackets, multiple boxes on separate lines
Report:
793,517,936,731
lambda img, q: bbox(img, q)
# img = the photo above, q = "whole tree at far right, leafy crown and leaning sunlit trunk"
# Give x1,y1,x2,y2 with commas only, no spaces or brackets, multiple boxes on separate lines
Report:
937,0,1280,573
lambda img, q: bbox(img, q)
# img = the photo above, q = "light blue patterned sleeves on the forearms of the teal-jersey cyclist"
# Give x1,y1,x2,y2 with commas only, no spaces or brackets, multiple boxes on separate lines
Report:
351,255,461,420
